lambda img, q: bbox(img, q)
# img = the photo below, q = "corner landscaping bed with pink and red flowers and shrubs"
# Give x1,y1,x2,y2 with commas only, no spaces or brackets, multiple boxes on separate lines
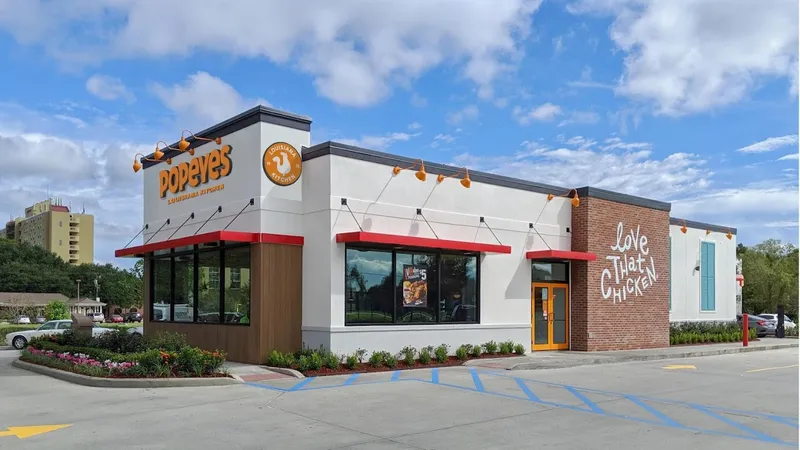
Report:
20,330,229,378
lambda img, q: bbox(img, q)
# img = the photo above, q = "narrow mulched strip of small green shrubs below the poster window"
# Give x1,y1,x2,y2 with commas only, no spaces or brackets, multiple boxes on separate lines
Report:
267,341,525,377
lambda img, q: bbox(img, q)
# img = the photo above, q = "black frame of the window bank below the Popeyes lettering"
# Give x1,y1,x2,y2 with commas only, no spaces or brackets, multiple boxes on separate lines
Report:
145,241,253,327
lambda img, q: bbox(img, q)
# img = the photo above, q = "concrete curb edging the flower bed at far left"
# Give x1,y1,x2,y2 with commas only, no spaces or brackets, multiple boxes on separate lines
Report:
11,359,242,388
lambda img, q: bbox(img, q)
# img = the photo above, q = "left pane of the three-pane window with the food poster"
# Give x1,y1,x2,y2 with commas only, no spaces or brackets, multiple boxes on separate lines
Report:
345,248,394,324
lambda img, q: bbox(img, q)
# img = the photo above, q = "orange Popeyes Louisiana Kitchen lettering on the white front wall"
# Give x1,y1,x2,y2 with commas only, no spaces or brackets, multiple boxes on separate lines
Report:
158,145,233,203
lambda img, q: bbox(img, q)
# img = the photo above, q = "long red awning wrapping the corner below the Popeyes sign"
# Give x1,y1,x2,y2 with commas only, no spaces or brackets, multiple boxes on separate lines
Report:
114,231,303,258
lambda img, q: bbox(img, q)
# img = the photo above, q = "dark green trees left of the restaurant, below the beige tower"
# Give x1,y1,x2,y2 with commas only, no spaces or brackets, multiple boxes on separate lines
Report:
0,238,143,308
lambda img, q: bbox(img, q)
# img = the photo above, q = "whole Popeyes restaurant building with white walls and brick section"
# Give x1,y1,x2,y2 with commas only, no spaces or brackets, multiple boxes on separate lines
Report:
116,106,737,363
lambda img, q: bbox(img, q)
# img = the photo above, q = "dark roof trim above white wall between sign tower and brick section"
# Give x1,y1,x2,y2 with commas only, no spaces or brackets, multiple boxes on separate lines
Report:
303,141,567,195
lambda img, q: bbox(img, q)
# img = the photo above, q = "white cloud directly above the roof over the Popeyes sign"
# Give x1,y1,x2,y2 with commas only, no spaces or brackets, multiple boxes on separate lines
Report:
152,72,269,126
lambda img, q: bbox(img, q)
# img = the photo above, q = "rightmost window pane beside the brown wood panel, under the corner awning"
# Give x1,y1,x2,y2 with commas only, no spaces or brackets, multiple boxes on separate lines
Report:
224,246,250,323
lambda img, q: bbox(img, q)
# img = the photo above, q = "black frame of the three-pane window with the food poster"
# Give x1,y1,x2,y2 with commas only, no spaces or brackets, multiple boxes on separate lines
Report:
343,244,482,327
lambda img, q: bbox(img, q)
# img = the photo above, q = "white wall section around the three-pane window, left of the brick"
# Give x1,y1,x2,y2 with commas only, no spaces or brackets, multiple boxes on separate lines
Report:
303,155,572,353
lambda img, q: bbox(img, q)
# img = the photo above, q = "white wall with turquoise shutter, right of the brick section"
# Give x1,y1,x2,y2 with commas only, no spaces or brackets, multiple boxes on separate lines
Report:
669,225,737,322
